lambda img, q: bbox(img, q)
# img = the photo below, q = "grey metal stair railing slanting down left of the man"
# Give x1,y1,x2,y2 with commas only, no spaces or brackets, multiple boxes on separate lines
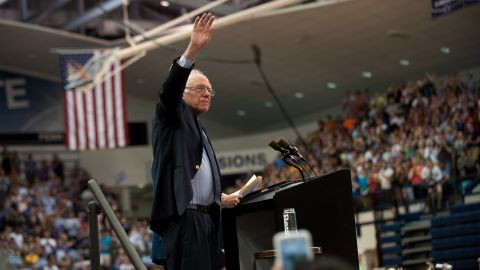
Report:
88,179,147,270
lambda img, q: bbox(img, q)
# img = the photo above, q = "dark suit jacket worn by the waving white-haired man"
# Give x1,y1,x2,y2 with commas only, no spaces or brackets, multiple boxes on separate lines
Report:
150,60,219,234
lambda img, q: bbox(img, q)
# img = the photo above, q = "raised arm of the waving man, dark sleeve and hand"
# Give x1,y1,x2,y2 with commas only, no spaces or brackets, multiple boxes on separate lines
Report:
160,13,215,111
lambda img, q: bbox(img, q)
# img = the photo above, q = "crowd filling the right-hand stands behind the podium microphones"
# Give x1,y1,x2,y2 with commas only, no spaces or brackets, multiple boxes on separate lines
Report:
263,73,480,215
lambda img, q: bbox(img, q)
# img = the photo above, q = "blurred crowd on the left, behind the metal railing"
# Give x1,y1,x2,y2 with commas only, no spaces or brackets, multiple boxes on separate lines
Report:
0,148,156,270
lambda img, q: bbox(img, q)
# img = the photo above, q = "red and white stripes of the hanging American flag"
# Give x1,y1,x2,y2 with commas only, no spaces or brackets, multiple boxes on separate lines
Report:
65,53,128,150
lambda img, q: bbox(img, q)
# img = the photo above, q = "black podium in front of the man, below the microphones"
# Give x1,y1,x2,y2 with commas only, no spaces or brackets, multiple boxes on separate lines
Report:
222,169,358,270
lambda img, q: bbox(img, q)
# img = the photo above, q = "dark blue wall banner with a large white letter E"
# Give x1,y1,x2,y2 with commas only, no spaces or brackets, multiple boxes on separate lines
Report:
0,71,64,134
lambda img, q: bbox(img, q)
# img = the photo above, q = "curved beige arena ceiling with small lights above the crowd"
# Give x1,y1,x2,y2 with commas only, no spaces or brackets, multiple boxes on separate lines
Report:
0,0,480,138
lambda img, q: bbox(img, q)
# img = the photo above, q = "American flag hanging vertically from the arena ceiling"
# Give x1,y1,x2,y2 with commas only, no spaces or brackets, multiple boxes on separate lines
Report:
60,51,129,150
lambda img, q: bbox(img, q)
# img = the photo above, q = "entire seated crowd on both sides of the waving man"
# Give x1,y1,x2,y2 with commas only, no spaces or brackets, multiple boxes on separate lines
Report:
0,70,480,270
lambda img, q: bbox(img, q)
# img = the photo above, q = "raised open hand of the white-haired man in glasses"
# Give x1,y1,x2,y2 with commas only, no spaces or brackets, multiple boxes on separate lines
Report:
184,13,215,59
